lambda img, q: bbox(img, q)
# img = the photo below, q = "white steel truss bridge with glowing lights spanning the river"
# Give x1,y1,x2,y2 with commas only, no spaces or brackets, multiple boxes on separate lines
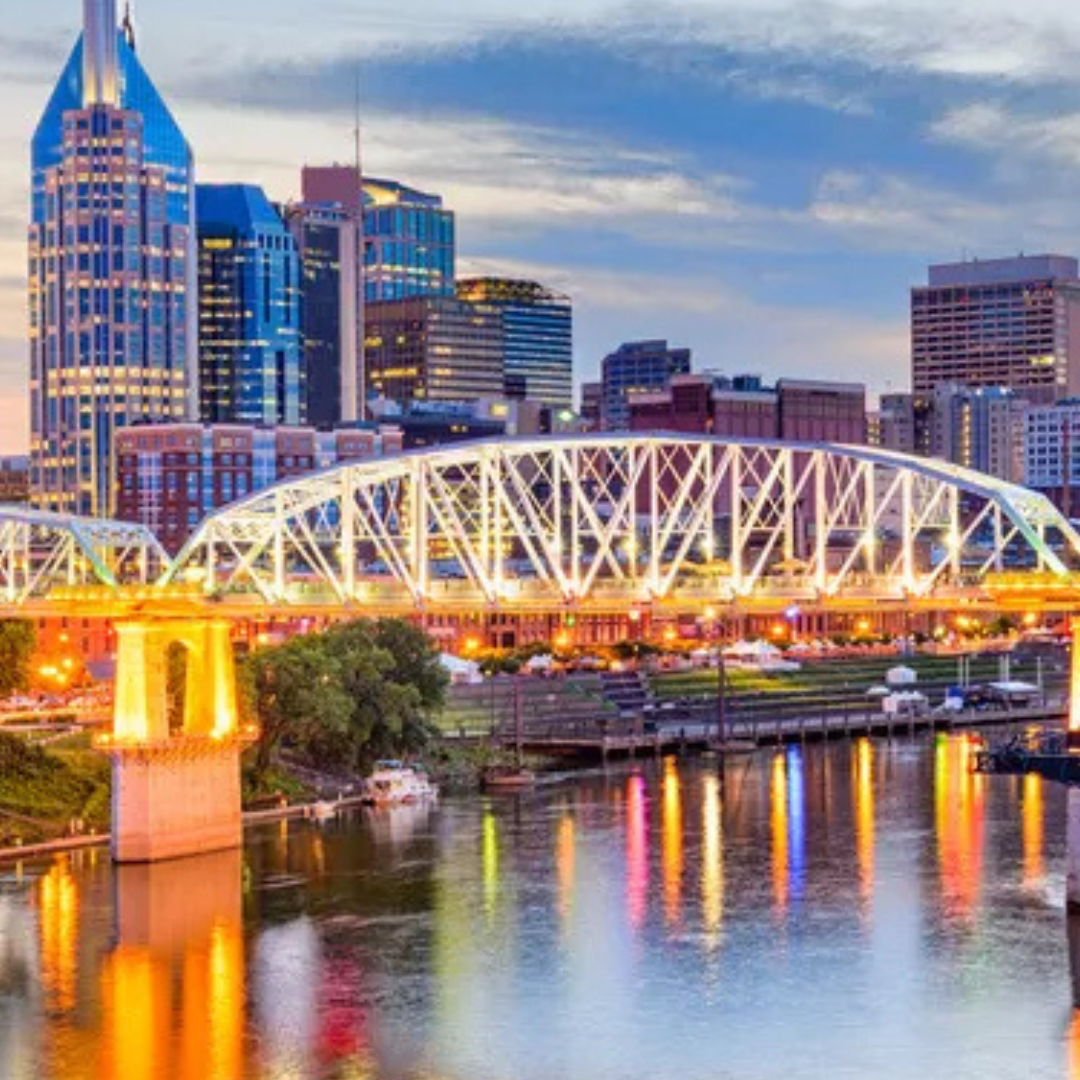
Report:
0,434,1080,615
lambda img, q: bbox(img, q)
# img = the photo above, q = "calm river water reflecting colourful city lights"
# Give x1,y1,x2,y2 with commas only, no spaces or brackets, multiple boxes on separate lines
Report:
0,737,1080,1080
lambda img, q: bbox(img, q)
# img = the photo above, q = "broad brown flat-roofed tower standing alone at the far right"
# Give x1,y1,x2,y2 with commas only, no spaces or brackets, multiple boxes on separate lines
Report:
912,255,1080,402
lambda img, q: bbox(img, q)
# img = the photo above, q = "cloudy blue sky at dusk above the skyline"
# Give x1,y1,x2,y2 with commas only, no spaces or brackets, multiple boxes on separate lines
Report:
0,0,1080,453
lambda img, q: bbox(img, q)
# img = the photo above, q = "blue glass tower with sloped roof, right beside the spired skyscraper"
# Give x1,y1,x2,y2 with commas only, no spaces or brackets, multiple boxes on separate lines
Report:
195,184,307,424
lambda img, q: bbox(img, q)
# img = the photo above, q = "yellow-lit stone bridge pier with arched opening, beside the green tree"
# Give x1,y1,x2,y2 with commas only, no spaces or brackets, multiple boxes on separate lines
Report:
98,618,253,863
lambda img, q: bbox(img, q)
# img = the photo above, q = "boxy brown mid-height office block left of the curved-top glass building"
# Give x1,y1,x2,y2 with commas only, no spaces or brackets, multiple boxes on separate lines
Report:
364,297,505,404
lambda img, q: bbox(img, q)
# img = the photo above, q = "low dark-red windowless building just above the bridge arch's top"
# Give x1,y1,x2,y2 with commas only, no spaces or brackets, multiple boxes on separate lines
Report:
629,375,866,444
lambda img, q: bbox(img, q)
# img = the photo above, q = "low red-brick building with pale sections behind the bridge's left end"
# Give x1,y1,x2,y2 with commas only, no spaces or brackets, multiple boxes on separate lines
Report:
117,423,402,553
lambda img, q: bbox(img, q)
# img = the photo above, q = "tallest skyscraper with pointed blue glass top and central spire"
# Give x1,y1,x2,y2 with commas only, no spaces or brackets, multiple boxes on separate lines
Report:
29,0,198,514
